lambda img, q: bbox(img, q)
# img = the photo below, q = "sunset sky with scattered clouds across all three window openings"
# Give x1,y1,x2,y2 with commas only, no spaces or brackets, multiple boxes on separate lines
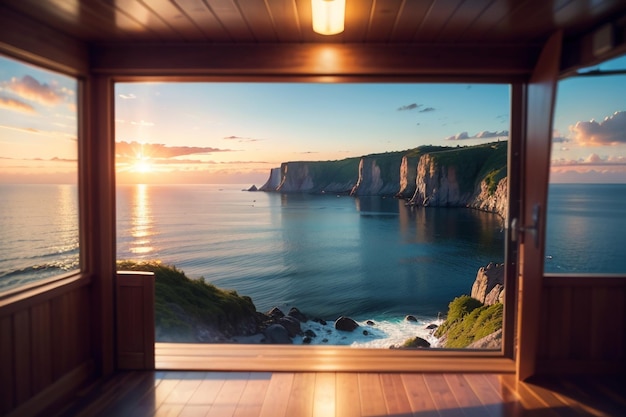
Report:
0,57,626,186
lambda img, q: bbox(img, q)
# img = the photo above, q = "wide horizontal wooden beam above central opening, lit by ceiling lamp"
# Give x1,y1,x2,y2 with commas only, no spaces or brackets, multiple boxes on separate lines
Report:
90,43,539,82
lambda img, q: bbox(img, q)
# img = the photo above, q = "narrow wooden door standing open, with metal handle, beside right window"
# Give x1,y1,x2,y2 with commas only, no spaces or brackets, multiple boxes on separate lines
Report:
517,32,563,380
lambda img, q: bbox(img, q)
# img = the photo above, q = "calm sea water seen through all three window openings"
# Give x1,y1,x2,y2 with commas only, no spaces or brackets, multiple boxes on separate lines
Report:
0,184,626,347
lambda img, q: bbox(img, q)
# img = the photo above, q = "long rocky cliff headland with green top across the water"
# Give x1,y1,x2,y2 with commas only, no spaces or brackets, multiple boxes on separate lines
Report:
260,142,507,218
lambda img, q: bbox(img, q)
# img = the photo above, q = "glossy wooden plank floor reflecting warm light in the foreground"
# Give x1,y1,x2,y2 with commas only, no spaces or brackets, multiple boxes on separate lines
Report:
53,371,626,417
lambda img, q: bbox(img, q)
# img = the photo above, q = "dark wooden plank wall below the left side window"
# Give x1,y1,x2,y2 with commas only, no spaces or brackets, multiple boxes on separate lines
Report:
0,277,94,416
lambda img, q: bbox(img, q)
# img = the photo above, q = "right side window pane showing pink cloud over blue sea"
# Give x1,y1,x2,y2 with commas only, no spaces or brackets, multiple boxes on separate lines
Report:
545,53,626,274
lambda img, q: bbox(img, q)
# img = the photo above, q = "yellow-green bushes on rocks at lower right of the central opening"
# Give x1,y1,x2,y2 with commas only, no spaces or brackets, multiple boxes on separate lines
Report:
435,295,503,348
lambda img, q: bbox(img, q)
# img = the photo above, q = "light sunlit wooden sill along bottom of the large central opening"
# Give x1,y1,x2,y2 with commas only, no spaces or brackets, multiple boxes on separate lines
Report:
155,343,515,373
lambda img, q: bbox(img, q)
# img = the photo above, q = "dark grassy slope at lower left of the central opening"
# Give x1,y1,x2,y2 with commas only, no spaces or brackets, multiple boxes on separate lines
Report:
117,261,256,341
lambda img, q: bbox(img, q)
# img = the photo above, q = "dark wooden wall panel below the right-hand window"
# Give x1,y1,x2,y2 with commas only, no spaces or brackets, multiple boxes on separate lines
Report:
537,276,626,374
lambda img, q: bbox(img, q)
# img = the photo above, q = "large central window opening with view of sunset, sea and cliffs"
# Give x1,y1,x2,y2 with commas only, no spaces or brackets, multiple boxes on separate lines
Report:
115,82,512,360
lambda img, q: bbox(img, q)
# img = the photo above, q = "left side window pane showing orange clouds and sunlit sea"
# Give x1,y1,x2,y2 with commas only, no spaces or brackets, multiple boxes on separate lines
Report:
0,56,79,291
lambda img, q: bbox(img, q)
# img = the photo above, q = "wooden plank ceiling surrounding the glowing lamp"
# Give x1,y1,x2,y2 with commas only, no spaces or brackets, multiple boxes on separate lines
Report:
2,0,626,45
